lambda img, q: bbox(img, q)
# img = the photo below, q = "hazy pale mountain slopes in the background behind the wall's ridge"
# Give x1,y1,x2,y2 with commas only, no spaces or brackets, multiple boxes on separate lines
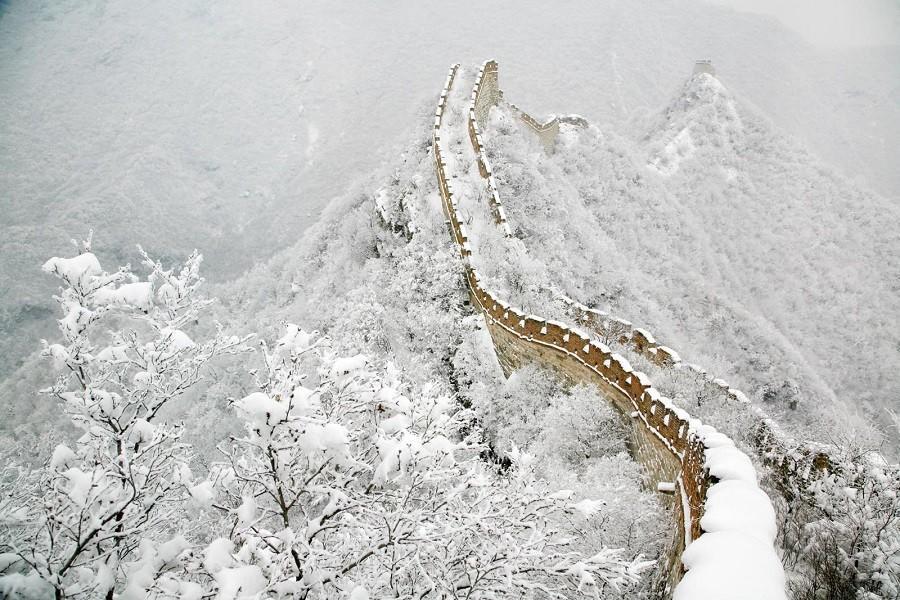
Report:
0,0,900,376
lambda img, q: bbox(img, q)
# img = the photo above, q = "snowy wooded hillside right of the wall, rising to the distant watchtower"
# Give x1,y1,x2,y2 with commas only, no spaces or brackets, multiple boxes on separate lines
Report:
484,74,900,448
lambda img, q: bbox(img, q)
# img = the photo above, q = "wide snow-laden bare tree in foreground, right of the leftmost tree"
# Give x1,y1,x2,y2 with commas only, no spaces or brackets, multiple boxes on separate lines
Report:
203,327,652,600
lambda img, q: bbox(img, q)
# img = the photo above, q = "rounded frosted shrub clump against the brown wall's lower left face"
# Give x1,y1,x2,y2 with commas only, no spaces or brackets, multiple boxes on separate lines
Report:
457,352,668,598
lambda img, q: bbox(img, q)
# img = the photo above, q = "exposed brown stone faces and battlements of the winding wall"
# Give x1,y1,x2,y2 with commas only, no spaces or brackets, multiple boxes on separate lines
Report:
433,61,777,597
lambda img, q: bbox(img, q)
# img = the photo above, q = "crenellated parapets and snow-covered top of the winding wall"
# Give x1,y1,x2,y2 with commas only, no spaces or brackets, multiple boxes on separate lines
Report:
433,61,785,600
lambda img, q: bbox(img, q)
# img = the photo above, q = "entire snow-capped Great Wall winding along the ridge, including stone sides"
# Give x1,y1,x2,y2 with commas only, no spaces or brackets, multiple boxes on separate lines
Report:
432,61,792,600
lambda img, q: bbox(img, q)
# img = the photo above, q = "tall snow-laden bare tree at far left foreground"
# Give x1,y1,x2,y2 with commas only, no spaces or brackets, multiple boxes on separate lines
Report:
0,239,243,598
